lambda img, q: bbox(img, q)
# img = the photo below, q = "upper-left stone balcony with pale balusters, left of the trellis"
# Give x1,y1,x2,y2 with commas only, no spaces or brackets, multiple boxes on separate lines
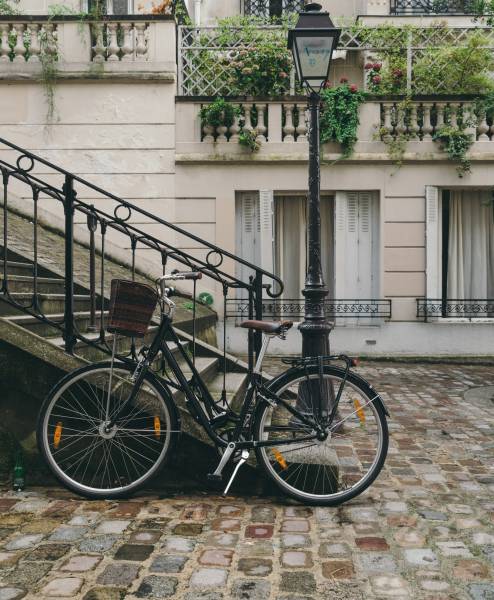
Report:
0,15,175,82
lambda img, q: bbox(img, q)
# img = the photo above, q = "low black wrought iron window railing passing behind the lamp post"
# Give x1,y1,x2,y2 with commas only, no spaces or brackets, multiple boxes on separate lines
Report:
225,298,391,324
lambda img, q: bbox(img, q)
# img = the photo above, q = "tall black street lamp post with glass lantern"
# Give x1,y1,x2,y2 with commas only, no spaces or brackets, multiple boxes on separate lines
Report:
288,2,341,360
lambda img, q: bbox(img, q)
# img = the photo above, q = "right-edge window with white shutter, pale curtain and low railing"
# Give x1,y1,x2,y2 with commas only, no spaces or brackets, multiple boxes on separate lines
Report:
427,187,494,318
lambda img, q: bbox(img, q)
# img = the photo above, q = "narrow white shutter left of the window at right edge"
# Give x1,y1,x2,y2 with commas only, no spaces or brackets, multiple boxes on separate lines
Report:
425,185,441,299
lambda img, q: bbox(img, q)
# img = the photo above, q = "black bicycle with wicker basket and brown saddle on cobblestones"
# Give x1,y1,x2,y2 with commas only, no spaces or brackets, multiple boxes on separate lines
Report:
37,272,389,506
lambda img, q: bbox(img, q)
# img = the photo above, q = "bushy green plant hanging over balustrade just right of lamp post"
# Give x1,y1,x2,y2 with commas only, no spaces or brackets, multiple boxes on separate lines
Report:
320,82,365,158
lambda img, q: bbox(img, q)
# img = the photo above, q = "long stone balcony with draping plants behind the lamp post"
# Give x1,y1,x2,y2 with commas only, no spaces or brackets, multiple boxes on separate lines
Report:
176,96,494,163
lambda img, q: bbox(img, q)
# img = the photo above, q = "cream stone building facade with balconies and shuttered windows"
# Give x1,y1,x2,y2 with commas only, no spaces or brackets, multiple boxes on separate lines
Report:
0,0,494,355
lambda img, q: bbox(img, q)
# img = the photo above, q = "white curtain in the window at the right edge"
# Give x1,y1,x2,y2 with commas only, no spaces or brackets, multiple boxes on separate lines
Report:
448,191,494,299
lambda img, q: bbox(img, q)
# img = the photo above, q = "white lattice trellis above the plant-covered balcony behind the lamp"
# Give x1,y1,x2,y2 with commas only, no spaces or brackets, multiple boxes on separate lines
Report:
179,26,494,96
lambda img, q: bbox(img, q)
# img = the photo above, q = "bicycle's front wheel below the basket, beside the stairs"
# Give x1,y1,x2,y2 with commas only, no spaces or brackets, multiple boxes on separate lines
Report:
37,363,178,498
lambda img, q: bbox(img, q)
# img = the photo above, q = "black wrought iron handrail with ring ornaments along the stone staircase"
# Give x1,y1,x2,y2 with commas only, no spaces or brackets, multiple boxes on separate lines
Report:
0,138,283,366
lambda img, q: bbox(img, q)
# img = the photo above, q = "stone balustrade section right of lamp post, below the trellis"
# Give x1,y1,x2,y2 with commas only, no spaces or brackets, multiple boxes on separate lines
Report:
380,99,494,141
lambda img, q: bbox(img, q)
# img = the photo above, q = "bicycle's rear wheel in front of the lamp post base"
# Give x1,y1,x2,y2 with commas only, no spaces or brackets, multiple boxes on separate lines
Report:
254,366,388,506
